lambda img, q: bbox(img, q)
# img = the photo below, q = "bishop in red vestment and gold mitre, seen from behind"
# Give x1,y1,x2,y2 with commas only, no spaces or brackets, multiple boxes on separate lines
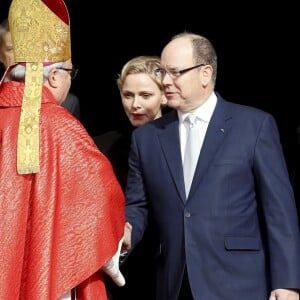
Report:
0,0,125,300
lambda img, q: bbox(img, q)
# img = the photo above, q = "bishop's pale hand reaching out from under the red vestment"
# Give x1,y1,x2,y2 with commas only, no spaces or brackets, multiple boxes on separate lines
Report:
102,237,125,286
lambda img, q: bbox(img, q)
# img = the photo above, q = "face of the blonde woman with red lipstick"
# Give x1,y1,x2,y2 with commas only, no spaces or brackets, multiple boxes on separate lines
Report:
120,73,165,127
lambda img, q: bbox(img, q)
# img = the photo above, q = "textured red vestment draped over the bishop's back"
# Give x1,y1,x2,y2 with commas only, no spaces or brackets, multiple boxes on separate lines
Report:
0,82,125,300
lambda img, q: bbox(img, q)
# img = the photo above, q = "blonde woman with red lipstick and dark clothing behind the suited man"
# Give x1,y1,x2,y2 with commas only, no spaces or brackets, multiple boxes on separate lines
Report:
94,56,166,300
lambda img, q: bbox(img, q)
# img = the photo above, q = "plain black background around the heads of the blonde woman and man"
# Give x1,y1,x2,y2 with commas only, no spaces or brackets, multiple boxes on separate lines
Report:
0,0,300,172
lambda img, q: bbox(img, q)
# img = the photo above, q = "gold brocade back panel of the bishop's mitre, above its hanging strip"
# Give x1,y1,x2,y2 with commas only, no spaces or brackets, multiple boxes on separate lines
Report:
9,0,71,62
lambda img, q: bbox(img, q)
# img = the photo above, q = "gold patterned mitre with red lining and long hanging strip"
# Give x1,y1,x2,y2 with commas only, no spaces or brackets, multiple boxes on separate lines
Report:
8,0,71,174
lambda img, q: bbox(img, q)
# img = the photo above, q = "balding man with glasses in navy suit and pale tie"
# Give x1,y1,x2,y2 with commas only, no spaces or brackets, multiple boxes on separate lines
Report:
123,32,300,300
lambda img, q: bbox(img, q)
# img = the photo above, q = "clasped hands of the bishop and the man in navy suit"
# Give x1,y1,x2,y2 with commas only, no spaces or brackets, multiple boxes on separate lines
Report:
102,223,132,286
